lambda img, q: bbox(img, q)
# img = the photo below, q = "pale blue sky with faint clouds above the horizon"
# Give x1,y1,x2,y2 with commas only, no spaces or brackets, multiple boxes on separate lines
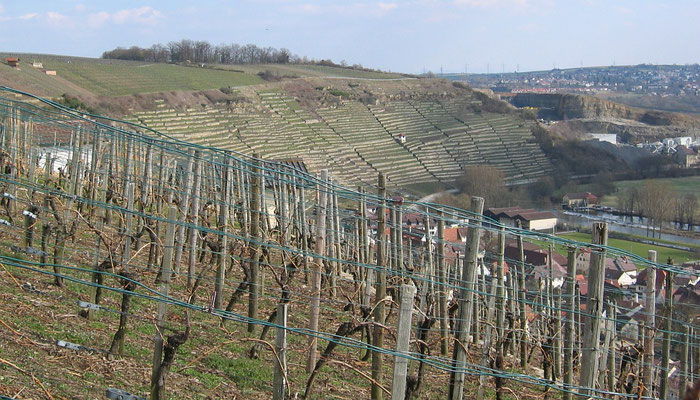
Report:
0,0,700,73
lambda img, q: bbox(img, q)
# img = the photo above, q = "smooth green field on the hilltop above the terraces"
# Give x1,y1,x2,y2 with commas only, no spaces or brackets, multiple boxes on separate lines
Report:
0,53,401,97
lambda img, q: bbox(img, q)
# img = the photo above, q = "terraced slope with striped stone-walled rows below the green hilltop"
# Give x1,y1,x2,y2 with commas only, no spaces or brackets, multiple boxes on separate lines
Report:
131,81,551,186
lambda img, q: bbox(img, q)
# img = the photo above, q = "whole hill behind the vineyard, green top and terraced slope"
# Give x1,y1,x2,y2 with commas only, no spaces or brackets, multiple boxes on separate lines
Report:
0,54,551,186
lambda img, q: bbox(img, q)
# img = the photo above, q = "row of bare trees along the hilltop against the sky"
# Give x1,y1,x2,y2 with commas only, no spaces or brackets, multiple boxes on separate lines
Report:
102,39,363,69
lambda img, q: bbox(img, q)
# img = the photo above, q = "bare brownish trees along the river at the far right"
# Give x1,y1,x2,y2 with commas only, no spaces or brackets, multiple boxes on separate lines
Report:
618,181,698,234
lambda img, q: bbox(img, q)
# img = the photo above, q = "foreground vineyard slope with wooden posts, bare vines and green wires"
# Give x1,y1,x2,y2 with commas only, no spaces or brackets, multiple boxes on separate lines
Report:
0,88,700,400
